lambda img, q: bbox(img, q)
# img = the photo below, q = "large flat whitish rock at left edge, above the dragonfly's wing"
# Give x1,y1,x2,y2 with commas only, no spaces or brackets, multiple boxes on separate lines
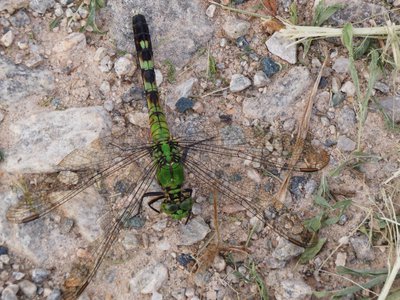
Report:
2,106,111,173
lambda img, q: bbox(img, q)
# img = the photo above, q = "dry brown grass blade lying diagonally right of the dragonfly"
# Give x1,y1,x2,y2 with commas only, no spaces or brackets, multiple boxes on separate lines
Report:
275,51,329,203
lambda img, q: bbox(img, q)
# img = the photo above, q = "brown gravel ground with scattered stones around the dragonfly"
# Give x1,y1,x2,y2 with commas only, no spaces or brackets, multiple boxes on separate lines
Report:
0,0,400,300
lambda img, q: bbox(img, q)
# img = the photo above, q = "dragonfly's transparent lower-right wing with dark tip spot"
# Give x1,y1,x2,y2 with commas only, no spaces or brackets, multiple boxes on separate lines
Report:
184,139,311,247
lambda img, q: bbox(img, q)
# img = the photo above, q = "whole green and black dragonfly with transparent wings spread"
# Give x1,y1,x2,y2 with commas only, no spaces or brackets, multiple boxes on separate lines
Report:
7,14,329,299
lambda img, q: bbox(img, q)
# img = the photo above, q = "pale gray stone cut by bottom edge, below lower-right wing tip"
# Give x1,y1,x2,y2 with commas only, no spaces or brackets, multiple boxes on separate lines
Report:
275,278,312,300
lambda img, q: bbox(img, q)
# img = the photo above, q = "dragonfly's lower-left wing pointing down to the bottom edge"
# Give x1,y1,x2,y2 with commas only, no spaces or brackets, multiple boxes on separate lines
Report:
64,162,156,300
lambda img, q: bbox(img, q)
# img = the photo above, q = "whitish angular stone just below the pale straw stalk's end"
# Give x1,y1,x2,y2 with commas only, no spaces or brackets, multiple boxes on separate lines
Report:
265,32,297,64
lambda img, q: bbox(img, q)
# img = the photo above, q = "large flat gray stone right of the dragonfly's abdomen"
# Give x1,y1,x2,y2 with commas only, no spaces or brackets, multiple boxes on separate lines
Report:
243,67,311,121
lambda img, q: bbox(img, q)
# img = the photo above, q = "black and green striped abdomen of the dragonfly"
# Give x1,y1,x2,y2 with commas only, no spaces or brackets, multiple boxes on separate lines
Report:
132,15,170,142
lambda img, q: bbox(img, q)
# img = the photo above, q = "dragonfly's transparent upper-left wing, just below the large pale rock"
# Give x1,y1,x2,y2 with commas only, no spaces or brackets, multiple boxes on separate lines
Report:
7,130,151,223
